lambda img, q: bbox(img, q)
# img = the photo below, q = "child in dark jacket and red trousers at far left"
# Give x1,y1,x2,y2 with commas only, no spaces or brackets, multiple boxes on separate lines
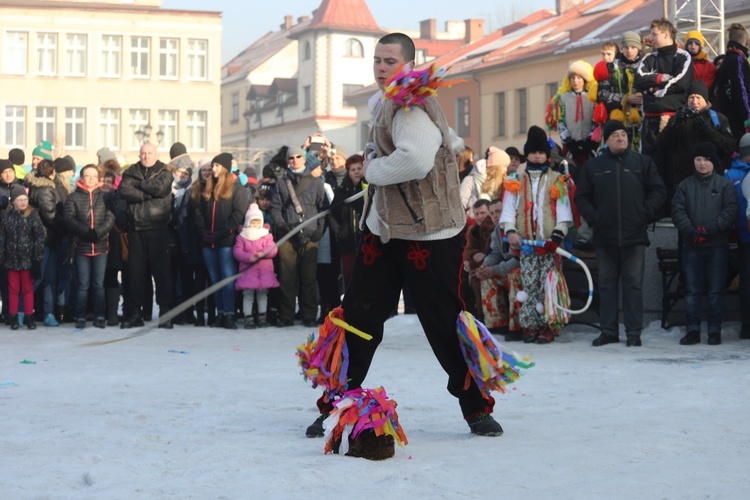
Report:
0,185,46,330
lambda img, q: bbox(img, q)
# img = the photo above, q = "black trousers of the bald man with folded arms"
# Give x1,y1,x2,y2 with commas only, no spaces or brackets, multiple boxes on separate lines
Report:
128,228,173,314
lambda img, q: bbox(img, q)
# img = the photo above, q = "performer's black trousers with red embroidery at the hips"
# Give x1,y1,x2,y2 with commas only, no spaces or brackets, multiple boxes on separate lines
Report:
342,231,493,417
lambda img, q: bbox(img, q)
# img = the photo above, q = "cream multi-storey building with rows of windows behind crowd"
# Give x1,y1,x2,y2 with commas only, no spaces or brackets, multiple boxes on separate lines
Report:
0,2,221,165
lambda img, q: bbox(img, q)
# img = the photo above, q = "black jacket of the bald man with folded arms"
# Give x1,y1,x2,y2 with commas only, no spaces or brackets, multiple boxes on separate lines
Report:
118,161,174,231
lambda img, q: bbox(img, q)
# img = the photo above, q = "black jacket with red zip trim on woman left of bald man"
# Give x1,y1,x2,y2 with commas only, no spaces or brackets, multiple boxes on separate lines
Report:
64,181,115,255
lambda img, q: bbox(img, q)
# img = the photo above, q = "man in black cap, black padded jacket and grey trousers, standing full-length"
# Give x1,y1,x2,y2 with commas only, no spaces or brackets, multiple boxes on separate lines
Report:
575,120,667,347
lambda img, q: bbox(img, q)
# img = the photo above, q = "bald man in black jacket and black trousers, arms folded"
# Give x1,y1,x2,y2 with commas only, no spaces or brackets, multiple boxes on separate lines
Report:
119,143,174,328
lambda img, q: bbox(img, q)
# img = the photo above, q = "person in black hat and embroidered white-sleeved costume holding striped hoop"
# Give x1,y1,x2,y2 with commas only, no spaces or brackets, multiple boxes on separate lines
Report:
500,126,573,344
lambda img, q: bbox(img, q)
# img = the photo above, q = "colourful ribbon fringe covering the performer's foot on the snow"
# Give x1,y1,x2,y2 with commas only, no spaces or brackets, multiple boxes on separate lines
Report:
323,386,408,455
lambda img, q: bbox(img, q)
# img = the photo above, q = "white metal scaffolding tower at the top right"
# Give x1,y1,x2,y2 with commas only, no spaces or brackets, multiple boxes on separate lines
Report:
664,0,726,57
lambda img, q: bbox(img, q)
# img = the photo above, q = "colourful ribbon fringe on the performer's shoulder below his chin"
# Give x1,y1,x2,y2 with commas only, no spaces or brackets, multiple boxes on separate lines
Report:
383,63,466,110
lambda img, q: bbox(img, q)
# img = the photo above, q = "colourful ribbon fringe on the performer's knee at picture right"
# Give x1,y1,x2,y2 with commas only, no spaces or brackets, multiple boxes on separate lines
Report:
456,311,534,397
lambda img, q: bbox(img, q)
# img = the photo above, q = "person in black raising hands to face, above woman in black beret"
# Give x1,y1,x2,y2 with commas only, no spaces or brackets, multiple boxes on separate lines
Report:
657,80,735,189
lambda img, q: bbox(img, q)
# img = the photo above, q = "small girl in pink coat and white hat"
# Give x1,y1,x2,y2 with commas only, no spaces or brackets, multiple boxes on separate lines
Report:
234,203,279,330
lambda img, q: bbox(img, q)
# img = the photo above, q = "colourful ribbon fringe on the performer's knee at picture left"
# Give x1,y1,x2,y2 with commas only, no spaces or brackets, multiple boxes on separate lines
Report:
297,307,372,395
